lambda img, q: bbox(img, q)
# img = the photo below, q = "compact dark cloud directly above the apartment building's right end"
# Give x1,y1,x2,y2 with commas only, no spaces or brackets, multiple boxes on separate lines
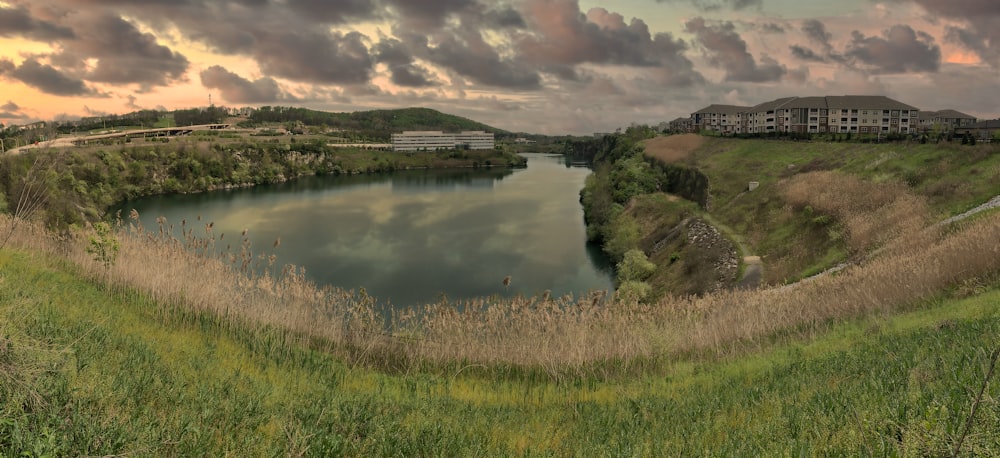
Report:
844,25,941,73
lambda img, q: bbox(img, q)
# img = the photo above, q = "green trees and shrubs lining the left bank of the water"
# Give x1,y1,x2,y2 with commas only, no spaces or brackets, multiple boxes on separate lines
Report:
0,134,525,228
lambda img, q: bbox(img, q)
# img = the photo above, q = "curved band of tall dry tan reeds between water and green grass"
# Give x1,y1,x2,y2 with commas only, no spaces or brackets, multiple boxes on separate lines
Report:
0,193,1000,376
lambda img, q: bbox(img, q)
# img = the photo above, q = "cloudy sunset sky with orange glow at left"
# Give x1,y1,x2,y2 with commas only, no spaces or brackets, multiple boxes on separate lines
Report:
0,0,1000,134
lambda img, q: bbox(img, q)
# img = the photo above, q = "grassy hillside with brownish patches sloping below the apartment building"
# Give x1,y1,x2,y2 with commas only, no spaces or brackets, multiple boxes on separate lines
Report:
647,136,1000,284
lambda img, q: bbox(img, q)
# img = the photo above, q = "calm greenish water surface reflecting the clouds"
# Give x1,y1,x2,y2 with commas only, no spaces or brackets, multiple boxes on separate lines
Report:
125,155,613,307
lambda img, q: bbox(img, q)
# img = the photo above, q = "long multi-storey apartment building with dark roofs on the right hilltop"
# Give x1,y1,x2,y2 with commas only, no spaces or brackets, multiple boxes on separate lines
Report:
691,95,919,135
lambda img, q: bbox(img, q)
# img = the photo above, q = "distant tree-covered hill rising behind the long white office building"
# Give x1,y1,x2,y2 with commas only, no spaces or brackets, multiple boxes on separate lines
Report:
250,106,511,138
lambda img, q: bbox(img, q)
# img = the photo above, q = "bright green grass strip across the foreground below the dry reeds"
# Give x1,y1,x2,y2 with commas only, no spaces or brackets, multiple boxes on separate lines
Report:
0,250,1000,456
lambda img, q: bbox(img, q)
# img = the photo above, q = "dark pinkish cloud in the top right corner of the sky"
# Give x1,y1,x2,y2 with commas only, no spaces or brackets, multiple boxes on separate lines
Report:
911,0,1000,67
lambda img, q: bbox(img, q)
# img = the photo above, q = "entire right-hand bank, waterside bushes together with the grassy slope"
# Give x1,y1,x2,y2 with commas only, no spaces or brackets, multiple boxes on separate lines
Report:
566,129,1000,298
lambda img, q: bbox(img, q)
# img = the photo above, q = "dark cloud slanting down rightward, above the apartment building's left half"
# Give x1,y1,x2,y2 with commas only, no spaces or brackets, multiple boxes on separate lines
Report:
684,17,787,83
